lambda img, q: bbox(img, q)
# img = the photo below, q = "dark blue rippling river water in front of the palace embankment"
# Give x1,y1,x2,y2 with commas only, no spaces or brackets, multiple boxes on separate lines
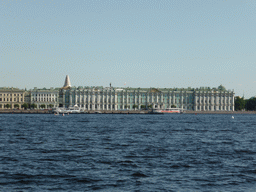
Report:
0,114,256,191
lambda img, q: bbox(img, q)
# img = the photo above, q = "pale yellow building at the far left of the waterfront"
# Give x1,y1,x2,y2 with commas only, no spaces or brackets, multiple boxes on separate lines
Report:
0,87,25,109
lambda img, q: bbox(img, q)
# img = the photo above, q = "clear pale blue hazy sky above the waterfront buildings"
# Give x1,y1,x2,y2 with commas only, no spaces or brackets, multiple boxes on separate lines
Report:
0,0,256,98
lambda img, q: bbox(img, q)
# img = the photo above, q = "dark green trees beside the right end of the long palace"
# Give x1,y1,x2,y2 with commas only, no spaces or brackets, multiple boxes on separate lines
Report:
235,97,256,111
